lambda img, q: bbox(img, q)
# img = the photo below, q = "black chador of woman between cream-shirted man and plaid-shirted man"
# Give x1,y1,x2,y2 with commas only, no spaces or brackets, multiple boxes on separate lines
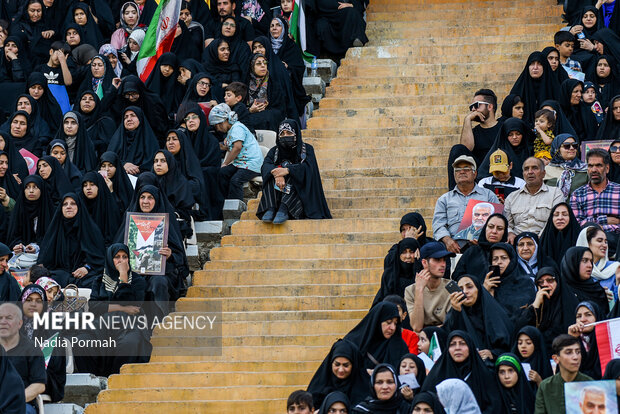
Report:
538,202,581,267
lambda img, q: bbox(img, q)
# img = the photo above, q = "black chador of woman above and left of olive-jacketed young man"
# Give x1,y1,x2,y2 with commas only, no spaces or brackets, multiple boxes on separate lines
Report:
536,268,581,357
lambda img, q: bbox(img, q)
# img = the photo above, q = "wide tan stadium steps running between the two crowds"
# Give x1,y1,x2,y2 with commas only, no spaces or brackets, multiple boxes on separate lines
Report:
86,0,561,414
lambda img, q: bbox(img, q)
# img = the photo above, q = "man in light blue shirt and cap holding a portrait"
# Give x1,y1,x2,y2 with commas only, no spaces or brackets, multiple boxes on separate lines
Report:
433,155,499,253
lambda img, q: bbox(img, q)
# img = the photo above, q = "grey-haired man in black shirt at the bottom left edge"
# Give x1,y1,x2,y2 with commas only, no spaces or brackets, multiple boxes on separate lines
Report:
0,302,47,414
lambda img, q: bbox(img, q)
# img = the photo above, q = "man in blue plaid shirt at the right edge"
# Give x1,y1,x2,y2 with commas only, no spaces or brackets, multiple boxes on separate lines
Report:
570,148,620,258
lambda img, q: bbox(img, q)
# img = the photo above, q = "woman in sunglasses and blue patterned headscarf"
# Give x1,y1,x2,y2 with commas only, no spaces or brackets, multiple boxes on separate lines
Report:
544,134,588,198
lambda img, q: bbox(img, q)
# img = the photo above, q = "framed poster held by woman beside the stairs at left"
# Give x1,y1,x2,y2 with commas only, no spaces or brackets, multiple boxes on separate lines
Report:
125,212,170,275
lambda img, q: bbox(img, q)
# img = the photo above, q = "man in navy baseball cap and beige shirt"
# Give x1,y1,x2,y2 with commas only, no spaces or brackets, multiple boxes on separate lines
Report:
405,242,456,332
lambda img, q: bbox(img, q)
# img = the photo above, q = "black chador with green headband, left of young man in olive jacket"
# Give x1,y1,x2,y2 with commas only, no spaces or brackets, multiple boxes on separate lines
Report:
495,353,536,414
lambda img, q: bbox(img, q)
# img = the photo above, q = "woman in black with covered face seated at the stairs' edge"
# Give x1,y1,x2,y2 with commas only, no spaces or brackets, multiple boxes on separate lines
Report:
256,119,332,224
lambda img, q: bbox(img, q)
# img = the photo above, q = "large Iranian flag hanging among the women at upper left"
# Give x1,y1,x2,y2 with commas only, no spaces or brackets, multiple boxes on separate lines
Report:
137,0,181,82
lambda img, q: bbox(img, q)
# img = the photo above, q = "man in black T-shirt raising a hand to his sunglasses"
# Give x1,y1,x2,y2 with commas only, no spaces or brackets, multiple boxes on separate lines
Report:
460,89,501,165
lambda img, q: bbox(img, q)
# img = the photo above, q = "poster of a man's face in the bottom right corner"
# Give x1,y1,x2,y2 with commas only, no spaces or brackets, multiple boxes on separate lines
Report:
564,380,618,414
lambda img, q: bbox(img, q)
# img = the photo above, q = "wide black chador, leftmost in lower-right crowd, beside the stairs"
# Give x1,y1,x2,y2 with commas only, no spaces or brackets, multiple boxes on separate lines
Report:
308,339,370,407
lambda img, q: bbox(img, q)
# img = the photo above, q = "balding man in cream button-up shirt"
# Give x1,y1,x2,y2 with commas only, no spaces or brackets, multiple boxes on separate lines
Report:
504,157,564,244
